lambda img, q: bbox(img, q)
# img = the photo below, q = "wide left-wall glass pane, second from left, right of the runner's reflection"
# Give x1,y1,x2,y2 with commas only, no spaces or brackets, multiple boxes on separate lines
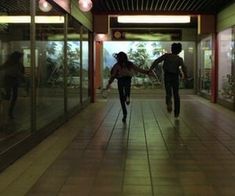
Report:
34,4,64,129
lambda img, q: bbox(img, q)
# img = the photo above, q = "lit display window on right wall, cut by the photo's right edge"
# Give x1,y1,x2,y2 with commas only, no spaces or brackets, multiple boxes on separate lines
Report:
218,28,234,103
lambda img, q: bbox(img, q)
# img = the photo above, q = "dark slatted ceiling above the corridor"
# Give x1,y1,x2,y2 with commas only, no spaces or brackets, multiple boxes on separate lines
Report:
92,0,235,14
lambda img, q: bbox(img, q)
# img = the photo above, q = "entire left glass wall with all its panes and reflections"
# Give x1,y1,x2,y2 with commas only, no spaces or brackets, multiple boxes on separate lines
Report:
0,0,90,168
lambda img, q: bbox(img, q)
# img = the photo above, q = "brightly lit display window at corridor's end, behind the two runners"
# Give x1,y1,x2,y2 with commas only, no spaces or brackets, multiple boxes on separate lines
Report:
103,41,196,89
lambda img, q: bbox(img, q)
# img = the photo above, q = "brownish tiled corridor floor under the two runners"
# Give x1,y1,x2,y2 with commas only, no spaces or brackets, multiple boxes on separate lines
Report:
0,95,235,196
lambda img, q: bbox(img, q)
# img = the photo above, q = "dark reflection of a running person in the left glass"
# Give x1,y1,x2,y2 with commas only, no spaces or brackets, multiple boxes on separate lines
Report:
0,51,24,119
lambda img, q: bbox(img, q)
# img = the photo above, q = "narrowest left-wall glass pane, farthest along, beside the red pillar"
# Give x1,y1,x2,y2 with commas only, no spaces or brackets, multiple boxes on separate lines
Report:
82,28,89,101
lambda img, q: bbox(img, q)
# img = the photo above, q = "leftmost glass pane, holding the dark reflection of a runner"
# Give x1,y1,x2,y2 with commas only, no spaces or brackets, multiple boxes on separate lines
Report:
0,1,31,150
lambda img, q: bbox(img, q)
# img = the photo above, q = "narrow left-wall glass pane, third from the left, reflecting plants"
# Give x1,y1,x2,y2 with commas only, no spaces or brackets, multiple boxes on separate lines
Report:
67,16,81,110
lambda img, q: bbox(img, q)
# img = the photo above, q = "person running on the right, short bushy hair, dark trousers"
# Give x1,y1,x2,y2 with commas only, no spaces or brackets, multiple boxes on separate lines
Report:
149,43,186,118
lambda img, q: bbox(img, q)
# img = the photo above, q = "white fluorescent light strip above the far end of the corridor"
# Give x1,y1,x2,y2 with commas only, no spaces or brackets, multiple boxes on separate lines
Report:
118,15,190,23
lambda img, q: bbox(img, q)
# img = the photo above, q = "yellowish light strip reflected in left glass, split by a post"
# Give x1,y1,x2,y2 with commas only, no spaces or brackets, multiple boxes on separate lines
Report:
0,16,64,24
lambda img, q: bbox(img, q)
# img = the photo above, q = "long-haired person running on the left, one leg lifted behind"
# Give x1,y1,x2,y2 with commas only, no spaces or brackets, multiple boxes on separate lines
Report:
106,52,148,123
